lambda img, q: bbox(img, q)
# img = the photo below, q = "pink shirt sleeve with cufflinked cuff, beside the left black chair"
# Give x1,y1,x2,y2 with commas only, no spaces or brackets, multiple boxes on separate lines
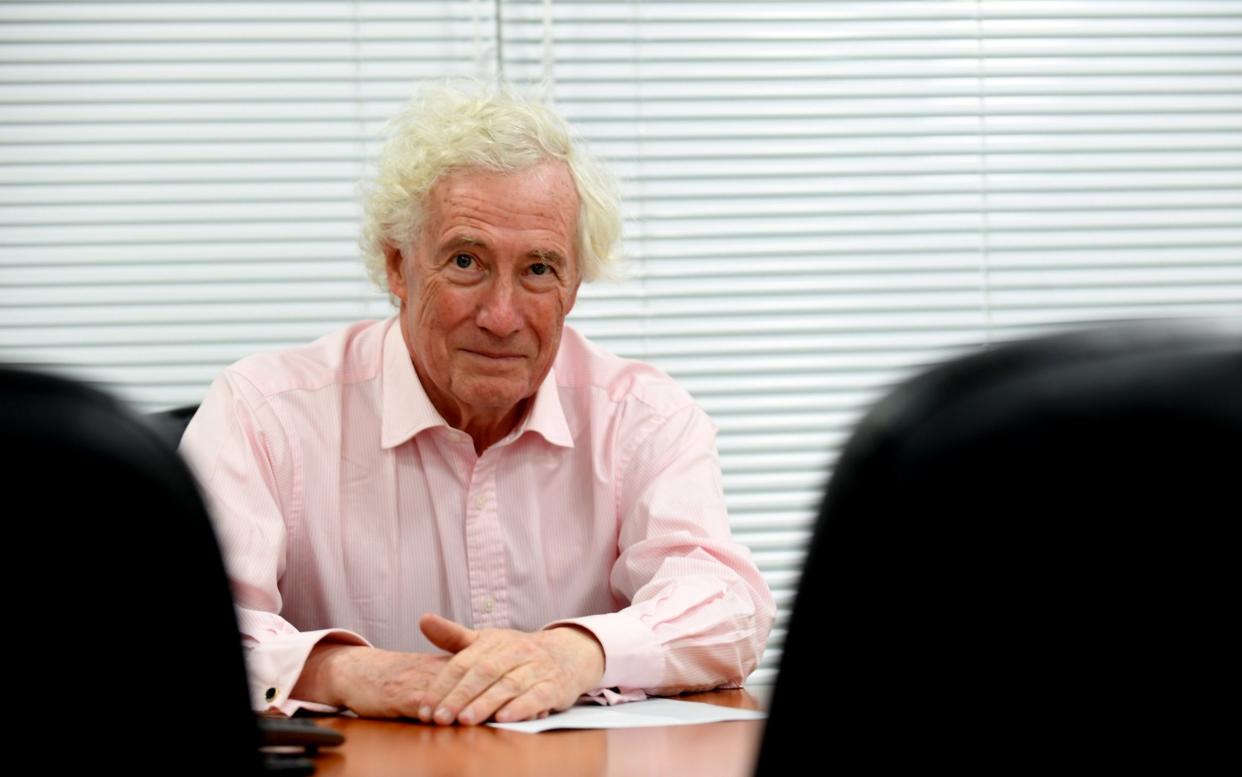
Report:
180,371,369,715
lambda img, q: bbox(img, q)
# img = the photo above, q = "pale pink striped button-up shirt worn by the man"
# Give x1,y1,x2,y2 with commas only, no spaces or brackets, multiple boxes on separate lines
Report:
181,311,775,714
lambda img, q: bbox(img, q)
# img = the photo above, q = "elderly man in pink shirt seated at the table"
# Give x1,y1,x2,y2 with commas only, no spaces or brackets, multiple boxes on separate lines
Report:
181,84,774,725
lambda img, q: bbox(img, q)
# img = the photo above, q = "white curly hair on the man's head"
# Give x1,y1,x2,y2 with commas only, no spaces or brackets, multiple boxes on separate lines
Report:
359,79,621,297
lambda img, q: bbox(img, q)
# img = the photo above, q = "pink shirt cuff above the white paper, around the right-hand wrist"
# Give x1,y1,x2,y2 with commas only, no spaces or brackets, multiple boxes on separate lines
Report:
544,612,664,704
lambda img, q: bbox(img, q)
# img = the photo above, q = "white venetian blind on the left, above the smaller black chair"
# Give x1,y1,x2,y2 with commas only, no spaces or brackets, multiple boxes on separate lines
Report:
0,1,496,408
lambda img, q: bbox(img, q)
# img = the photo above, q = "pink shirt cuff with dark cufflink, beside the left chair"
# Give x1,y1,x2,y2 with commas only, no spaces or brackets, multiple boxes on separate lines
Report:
246,628,371,715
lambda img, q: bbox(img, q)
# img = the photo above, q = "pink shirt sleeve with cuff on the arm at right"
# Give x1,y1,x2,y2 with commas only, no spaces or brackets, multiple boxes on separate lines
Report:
546,406,776,703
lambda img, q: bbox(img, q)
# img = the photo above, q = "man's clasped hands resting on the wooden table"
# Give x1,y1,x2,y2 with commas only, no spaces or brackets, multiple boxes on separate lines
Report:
301,613,604,725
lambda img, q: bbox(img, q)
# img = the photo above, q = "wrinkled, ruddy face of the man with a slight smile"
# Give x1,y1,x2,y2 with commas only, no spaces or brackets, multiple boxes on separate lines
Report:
389,161,580,433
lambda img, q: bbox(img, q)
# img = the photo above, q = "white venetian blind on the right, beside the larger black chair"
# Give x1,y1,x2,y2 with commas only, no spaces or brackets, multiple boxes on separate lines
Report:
502,0,1242,680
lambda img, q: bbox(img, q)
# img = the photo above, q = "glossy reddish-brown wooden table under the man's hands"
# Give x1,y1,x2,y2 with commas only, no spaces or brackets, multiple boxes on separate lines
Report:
305,686,769,777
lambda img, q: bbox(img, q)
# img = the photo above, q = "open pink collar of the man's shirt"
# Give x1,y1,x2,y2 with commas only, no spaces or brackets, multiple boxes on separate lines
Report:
380,317,574,449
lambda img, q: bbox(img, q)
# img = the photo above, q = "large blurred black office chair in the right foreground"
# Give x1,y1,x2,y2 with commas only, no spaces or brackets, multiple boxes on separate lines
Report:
758,323,1242,776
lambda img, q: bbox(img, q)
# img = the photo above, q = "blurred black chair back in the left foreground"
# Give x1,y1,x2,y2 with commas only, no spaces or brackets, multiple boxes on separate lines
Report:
0,367,261,775
